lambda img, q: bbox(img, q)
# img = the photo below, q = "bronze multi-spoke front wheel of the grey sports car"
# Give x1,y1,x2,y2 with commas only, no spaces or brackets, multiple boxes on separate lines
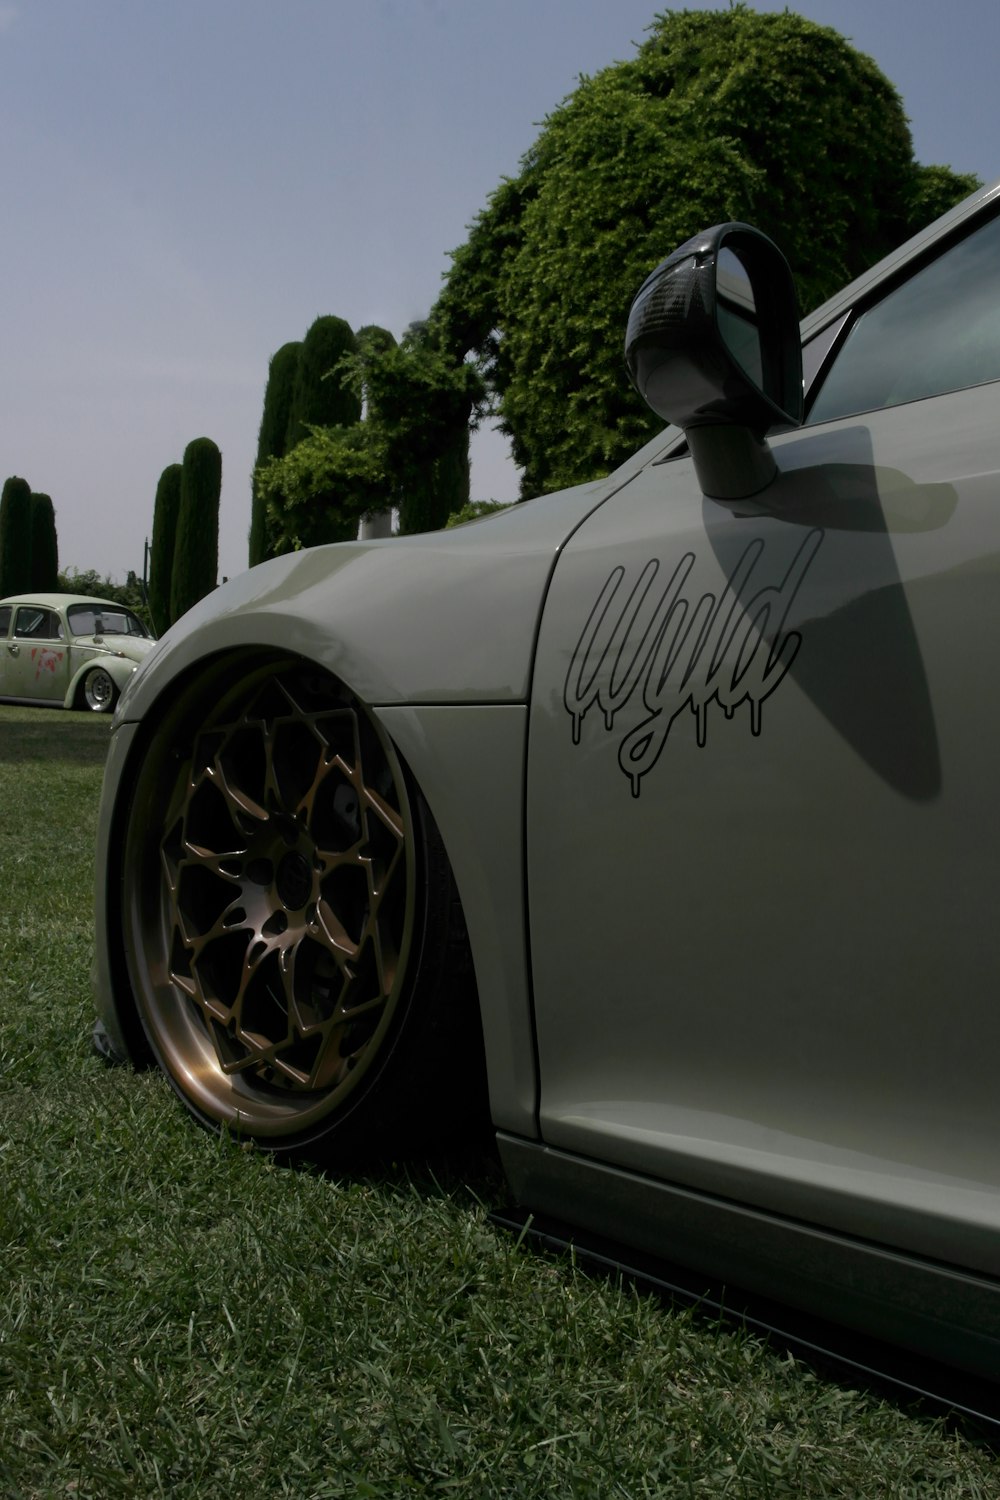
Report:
123,662,475,1152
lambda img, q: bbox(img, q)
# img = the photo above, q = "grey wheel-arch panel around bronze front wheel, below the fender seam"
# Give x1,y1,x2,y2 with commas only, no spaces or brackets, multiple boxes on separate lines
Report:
94,644,537,1136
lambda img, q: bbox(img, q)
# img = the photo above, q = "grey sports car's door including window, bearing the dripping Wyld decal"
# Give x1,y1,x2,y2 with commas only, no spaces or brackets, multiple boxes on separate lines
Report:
526,199,1000,1274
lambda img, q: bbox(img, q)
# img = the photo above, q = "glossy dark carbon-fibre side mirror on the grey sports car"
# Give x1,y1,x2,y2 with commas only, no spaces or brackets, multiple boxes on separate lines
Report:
625,224,802,500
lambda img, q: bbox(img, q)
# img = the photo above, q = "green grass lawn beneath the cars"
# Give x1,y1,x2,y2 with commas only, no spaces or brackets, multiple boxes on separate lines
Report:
0,708,1000,1500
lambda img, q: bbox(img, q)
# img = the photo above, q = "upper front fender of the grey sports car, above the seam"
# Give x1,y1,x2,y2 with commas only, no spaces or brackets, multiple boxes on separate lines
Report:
118,477,618,722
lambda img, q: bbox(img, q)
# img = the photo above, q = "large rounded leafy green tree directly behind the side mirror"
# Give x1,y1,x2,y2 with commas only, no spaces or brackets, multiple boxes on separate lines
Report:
432,5,975,495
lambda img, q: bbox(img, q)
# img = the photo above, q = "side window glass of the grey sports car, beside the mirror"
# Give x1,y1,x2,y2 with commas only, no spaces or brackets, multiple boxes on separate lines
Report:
805,218,1000,425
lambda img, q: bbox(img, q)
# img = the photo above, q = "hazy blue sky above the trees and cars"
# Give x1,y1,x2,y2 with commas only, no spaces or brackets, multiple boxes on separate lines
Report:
0,0,1000,578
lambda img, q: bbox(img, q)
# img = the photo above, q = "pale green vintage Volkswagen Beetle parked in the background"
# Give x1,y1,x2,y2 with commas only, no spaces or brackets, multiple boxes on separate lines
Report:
0,593,153,714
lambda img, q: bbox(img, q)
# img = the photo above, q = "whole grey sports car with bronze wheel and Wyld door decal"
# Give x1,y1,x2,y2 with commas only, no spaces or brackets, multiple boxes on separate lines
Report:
96,175,1000,1379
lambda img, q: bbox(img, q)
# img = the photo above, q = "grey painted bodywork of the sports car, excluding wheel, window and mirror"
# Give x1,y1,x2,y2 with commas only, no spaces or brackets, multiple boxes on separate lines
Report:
96,186,1000,1379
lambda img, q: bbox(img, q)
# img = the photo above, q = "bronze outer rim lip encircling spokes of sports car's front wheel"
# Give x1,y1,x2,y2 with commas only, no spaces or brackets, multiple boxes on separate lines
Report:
121,657,417,1151
